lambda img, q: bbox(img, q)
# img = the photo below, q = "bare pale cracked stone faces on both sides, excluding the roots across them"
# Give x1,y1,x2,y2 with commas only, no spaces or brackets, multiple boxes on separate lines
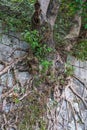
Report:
0,30,87,130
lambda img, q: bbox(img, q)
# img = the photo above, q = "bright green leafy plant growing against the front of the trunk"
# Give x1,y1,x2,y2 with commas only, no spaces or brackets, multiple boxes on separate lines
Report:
23,30,52,72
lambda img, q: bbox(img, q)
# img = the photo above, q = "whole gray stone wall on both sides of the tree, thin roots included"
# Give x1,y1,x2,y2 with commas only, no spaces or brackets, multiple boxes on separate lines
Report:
0,28,87,130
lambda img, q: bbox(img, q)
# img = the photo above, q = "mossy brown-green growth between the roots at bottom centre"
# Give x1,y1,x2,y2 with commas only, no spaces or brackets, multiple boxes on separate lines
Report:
18,91,46,130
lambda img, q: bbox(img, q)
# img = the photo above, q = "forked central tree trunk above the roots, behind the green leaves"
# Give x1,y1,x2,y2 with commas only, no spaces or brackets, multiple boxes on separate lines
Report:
32,0,60,48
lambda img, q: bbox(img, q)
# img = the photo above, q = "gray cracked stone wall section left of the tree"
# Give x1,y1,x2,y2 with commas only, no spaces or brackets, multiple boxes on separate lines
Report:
0,31,31,130
